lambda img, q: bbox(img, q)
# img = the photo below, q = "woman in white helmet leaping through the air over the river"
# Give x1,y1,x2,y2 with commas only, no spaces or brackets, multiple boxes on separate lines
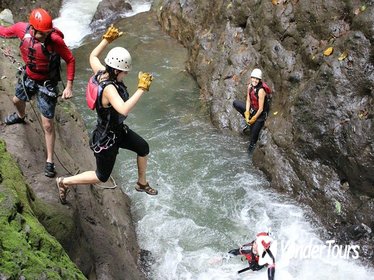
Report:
56,26,158,204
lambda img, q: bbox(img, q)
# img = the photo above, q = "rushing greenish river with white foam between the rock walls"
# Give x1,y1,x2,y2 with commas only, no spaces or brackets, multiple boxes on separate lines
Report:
55,0,373,280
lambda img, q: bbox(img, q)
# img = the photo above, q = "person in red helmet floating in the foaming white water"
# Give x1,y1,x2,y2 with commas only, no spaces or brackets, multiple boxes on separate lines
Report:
228,232,275,280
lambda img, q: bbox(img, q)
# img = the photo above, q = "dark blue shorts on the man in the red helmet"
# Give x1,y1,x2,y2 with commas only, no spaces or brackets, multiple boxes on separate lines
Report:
16,76,58,119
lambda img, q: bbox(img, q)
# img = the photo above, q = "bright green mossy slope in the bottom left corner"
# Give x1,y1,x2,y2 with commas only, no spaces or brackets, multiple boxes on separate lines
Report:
0,140,86,279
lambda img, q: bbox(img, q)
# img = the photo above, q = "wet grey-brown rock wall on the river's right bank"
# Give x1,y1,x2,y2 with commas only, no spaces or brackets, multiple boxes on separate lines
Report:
153,0,374,262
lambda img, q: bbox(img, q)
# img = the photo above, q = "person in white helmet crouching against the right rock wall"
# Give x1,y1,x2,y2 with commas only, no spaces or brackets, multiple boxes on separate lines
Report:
233,68,271,154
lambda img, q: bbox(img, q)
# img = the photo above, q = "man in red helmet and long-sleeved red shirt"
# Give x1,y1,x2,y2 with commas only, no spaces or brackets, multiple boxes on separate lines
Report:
0,8,75,178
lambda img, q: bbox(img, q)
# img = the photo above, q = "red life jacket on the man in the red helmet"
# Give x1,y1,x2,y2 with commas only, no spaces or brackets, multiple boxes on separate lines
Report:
19,25,61,81
